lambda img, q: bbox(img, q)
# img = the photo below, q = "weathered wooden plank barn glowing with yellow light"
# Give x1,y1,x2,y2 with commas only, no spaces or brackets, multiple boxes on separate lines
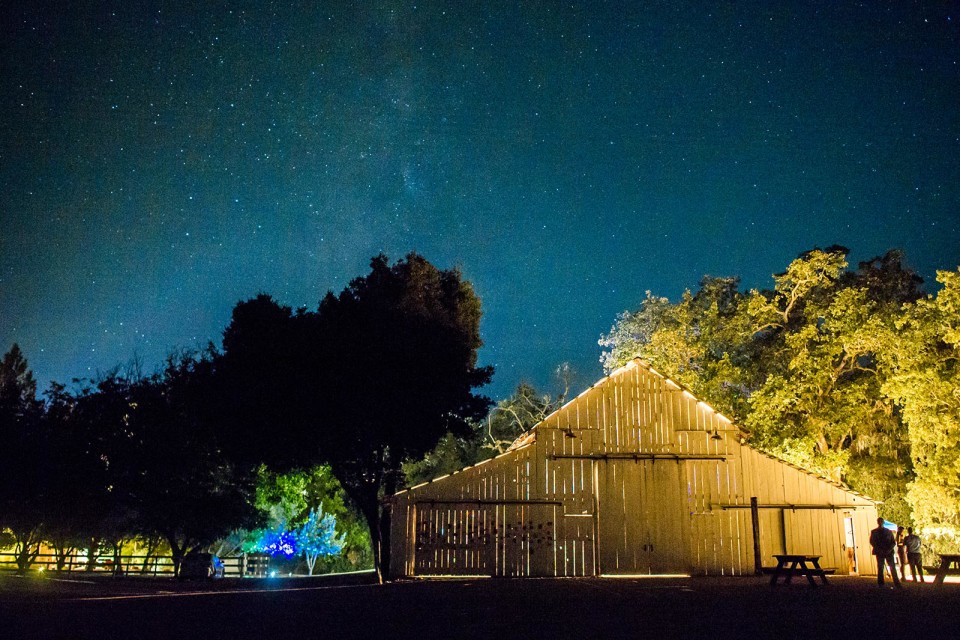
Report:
390,360,877,576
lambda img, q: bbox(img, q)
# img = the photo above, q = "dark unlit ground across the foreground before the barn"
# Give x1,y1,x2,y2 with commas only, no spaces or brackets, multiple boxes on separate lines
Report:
0,575,960,640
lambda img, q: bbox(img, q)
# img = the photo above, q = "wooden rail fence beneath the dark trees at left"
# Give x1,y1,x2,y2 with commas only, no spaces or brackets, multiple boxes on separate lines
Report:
0,553,269,578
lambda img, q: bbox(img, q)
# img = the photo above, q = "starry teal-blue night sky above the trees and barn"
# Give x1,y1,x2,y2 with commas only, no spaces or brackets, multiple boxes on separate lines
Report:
0,0,960,398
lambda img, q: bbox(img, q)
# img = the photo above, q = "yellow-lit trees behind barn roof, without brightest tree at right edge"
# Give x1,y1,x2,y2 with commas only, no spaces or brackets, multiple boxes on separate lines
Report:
600,247,921,522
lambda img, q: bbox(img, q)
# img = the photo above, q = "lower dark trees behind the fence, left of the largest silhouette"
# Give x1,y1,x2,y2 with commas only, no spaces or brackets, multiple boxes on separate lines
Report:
0,349,257,570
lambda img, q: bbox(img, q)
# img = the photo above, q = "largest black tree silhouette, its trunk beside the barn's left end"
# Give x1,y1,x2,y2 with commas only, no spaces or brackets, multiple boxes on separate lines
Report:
218,253,492,577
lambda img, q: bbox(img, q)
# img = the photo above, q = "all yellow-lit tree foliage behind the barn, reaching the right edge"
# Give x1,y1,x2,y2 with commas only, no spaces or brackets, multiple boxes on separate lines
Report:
600,246,960,542
